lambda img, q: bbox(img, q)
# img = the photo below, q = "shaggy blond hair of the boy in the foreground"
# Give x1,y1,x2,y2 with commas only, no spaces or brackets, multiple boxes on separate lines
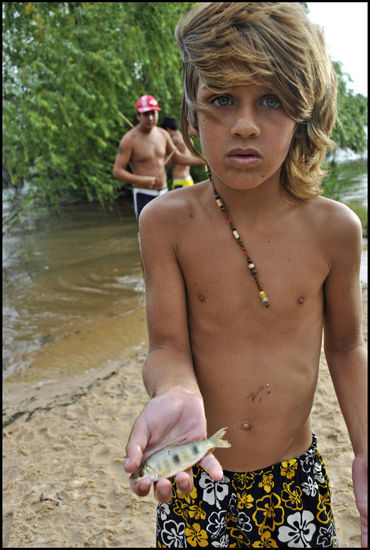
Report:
175,2,337,199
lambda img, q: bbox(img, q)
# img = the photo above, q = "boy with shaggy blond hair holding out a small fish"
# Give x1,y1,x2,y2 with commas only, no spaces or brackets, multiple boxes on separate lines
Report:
125,2,367,548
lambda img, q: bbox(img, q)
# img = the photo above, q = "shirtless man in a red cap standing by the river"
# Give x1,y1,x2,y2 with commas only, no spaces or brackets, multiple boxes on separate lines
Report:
113,95,204,220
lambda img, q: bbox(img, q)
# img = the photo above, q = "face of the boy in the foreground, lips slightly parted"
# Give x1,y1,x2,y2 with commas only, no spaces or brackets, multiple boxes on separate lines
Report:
197,83,296,189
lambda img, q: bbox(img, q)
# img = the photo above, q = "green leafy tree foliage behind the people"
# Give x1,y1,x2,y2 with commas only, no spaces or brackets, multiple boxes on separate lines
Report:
2,2,367,213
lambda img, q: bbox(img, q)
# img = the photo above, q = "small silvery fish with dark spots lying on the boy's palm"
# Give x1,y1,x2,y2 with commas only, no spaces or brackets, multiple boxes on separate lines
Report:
130,428,231,481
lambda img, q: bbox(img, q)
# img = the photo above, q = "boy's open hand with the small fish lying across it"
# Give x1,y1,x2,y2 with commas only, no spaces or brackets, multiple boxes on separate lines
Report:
125,388,223,502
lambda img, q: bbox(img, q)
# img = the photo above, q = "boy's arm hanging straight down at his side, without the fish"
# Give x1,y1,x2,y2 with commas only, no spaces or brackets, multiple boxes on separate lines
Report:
324,206,367,547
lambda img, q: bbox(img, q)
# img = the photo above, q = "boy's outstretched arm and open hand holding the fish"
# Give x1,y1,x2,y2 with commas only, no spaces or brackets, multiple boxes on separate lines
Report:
125,196,223,502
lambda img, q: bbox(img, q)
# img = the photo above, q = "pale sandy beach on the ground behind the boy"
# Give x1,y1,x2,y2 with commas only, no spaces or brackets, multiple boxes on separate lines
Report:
3,287,367,548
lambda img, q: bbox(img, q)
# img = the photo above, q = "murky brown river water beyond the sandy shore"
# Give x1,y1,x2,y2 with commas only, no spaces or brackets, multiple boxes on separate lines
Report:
3,176,367,381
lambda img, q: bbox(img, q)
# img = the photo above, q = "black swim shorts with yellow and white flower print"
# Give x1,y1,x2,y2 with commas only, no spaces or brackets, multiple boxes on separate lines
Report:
157,435,337,548
